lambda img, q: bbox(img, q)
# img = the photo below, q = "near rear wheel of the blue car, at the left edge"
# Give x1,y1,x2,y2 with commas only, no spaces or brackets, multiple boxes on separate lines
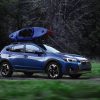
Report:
0,62,13,77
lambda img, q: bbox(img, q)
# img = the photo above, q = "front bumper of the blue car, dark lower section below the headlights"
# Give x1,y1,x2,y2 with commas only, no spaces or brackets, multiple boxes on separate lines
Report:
66,62,92,74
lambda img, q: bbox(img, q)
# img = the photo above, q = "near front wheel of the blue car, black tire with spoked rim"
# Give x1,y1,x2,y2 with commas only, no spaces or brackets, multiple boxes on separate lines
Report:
47,62,62,79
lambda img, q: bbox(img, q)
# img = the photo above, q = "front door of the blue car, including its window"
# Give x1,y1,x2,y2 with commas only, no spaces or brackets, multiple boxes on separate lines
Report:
24,44,45,70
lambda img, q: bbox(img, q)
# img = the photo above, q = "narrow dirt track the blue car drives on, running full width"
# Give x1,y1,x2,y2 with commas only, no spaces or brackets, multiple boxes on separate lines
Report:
0,73,100,82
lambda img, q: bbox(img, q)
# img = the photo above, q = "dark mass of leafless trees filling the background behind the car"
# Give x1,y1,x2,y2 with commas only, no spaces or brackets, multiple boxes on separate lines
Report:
0,0,100,56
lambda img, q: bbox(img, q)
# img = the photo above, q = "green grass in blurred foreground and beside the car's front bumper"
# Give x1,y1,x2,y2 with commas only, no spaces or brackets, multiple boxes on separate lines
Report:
0,62,100,100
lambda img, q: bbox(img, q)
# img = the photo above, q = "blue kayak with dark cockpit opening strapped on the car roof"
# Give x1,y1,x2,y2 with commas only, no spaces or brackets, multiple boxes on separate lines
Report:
9,27,52,42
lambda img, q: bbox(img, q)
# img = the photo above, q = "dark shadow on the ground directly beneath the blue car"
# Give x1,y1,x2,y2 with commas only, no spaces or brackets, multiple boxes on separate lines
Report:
0,73,91,80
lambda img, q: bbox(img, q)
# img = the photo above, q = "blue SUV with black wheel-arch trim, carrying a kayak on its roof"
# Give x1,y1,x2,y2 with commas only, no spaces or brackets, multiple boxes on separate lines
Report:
0,43,91,79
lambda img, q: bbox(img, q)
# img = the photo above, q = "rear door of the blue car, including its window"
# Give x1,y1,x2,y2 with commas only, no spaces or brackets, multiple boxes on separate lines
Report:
9,44,26,69
